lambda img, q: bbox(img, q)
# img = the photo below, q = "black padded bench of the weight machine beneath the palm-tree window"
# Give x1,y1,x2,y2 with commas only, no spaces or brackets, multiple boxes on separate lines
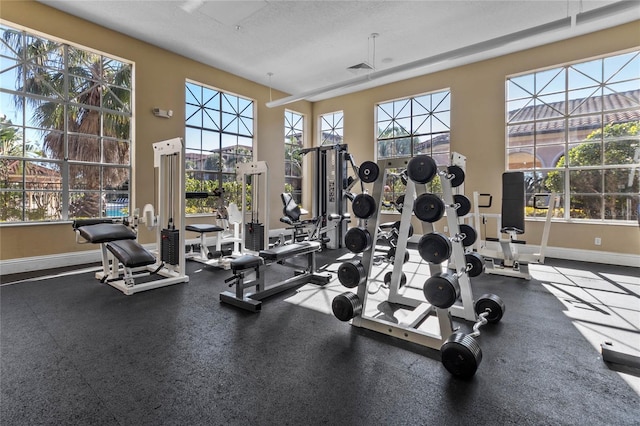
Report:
72,219,162,287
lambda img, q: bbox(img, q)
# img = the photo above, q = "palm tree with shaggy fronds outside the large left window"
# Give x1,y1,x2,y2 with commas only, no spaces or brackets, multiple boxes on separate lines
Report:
3,28,131,217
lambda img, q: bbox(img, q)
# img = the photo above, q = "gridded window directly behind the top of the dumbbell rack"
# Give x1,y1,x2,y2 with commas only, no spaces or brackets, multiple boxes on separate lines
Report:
376,90,451,207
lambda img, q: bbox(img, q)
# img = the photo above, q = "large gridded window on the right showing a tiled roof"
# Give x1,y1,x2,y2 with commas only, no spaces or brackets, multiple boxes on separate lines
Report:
506,51,640,221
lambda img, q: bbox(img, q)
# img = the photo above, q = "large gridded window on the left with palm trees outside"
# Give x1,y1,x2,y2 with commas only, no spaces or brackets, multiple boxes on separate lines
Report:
0,25,133,222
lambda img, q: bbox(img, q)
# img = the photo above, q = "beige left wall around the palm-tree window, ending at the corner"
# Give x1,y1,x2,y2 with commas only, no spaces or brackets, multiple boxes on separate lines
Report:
0,1,311,259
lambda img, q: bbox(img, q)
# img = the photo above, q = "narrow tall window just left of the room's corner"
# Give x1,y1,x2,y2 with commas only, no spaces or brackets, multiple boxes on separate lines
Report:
284,111,304,204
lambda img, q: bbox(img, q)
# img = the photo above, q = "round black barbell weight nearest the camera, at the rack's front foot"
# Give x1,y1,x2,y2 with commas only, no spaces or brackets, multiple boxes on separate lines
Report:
440,333,482,379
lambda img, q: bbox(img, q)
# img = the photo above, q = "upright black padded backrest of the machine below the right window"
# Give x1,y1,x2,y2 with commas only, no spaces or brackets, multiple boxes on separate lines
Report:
500,172,525,234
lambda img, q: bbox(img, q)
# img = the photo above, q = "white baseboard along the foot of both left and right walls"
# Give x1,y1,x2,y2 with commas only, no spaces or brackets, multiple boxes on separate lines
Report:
0,240,640,281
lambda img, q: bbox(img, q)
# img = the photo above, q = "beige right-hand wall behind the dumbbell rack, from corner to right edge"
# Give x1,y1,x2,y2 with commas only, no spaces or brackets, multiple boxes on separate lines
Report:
313,21,640,255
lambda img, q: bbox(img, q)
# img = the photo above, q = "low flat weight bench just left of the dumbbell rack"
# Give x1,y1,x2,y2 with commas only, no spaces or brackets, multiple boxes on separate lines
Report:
220,241,331,312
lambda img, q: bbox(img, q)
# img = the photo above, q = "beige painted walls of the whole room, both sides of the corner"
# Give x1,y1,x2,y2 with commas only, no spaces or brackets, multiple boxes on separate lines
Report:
0,0,640,260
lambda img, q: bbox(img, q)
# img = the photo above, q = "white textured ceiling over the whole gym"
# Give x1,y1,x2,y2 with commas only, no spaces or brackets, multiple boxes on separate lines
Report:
39,0,640,104
